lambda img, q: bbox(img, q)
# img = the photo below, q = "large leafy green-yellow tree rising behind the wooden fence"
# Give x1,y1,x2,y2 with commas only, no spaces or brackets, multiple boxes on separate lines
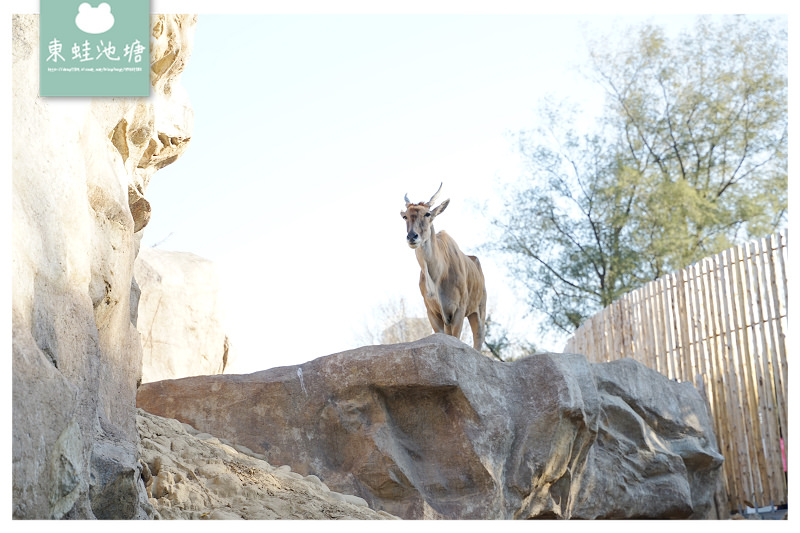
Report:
492,16,788,333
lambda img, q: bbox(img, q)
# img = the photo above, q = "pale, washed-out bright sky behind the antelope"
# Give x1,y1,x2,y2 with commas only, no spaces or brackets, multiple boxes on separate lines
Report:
6,0,792,373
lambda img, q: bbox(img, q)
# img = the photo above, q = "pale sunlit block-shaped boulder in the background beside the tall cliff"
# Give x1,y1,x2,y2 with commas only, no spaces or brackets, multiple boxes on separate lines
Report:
134,248,230,383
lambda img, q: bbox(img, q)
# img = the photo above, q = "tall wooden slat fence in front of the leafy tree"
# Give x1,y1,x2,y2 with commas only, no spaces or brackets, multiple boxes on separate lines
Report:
564,230,789,509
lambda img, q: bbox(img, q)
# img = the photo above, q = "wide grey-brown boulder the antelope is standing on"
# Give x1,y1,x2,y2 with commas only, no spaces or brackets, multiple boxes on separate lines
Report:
137,334,722,519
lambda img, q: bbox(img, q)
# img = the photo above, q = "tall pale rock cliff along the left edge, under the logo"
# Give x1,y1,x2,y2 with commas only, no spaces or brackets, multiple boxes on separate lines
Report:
11,15,195,519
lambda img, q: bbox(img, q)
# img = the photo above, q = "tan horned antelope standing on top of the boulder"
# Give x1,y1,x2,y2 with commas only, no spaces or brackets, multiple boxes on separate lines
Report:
400,184,486,351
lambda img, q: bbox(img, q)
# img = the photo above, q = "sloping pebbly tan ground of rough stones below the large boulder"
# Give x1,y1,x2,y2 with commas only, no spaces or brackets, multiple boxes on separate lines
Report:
137,410,396,520
